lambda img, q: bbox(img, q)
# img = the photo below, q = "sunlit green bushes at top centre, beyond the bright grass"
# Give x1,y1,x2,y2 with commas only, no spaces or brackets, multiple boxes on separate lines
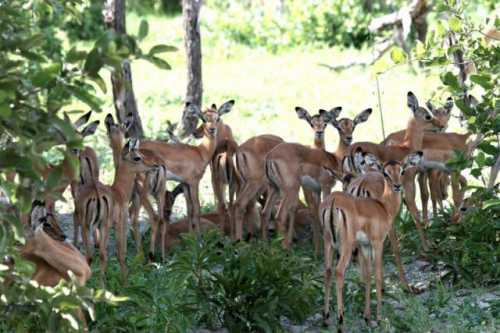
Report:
206,0,404,52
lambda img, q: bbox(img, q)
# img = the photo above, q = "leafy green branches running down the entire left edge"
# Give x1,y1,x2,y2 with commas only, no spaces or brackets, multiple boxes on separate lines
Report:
0,0,175,331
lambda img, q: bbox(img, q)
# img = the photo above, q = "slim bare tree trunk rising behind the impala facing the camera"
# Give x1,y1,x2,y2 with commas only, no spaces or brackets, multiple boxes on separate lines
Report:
182,0,203,108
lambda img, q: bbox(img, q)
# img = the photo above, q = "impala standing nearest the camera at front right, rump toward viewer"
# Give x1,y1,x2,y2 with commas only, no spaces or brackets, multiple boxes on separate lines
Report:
320,151,423,330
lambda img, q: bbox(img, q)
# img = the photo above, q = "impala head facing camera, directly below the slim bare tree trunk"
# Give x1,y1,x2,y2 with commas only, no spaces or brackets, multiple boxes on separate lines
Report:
182,100,234,138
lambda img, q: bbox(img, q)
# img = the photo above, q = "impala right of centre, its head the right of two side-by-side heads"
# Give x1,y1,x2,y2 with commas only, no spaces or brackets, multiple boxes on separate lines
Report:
263,107,372,253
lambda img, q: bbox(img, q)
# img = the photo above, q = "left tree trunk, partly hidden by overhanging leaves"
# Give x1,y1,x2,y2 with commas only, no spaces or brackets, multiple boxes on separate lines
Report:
103,0,144,138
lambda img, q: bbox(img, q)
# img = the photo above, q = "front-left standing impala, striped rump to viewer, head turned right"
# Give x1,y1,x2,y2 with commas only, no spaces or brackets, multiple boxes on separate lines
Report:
74,139,157,284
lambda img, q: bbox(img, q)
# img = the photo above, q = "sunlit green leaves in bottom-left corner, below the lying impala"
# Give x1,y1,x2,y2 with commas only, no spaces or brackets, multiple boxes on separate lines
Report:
0,250,124,332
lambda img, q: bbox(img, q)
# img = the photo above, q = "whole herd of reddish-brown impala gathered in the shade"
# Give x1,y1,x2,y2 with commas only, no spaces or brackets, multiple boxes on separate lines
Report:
14,92,480,328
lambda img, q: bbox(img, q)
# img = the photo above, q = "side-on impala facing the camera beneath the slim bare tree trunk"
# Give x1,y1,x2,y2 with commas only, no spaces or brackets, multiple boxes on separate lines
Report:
141,100,234,232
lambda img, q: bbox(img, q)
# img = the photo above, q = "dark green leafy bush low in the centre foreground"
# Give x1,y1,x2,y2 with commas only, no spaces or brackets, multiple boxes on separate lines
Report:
169,231,321,332
